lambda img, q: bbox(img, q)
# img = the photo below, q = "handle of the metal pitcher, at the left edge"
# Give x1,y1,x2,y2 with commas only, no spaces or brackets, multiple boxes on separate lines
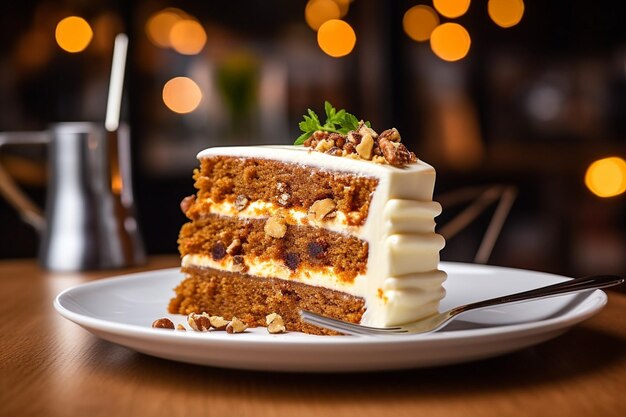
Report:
0,131,50,233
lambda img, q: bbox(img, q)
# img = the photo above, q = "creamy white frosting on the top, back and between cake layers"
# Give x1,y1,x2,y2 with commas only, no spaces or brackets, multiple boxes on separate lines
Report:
189,146,446,326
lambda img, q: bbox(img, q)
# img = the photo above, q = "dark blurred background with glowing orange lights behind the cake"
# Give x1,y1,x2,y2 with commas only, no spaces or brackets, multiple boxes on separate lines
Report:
0,0,626,275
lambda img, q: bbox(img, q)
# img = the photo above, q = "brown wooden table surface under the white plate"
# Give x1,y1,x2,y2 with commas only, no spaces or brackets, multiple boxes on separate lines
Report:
0,257,626,417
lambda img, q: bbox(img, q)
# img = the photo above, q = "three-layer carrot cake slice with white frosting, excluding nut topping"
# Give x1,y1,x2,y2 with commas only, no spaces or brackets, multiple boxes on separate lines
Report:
169,146,446,334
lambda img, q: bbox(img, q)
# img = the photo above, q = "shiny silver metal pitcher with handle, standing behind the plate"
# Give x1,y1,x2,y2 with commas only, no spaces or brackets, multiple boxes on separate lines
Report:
0,122,145,271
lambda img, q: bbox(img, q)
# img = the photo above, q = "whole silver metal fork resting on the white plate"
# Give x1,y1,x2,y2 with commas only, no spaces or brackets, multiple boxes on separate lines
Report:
300,275,624,335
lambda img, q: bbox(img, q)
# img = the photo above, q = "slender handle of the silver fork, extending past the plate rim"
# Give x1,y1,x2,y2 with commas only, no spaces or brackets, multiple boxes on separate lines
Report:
451,275,624,315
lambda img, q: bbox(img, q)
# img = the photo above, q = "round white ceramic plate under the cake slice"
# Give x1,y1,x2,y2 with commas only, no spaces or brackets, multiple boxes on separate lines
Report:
54,263,607,372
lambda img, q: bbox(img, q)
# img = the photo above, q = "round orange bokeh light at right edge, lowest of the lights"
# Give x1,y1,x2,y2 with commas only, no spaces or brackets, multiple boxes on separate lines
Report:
585,156,626,197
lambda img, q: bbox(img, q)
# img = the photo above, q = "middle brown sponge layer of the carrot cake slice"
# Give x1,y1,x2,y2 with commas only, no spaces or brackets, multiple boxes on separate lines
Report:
179,214,368,284
